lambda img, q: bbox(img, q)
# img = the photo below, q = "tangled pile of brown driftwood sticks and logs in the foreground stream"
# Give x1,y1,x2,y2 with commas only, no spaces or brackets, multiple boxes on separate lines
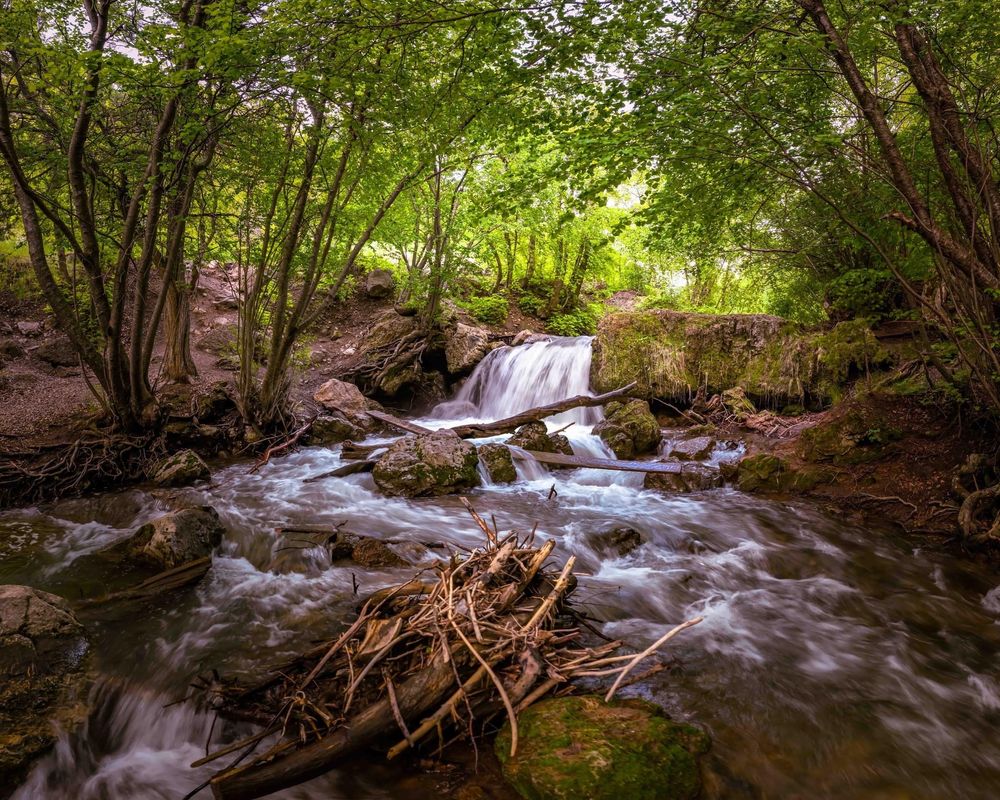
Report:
192,499,700,800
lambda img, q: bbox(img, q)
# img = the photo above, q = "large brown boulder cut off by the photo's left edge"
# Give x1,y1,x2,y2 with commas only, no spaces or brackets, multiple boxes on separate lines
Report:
0,585,90,794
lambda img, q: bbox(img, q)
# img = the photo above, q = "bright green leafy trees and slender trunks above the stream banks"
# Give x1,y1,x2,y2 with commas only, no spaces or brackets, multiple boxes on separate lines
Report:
0,0,1000,429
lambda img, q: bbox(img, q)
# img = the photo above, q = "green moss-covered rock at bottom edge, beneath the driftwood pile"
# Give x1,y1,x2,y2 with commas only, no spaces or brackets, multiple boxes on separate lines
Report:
495,696,709,800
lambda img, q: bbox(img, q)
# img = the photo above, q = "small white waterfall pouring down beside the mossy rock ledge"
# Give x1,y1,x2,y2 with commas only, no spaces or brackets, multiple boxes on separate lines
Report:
434,336,601,425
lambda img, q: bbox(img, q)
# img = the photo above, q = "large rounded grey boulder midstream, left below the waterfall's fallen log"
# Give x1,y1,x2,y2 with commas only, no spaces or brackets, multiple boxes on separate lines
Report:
372,431,479,497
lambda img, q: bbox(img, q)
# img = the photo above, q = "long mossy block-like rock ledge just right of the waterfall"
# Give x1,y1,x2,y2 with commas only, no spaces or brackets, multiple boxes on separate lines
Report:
591,310,887,408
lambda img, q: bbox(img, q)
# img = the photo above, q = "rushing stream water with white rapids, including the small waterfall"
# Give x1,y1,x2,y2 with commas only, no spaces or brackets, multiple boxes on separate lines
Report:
0,338,1000,800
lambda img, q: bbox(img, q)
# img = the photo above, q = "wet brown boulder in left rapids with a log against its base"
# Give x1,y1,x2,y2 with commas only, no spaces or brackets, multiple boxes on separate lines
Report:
108,506,226,570
